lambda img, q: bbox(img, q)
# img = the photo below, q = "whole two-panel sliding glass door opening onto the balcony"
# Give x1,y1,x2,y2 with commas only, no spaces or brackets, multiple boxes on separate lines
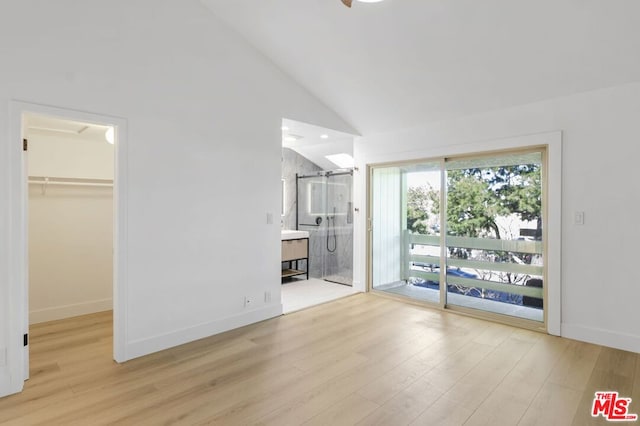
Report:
370,150,544,322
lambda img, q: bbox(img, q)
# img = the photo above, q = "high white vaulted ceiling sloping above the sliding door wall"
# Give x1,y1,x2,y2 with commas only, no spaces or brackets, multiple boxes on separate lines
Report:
202,0,640,135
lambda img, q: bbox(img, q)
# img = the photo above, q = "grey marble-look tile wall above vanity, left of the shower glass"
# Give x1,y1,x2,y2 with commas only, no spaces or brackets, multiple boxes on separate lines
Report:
282,148,322,229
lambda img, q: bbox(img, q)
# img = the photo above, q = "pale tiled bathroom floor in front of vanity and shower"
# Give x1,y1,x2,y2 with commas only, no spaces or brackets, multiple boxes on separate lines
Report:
282,278,357,314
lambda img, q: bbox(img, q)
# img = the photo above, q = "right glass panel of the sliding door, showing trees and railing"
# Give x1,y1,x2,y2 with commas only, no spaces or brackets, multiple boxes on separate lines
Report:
445,152,544,321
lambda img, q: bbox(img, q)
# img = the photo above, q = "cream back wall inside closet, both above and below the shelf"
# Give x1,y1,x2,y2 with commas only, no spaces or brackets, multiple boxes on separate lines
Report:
25,125,114,324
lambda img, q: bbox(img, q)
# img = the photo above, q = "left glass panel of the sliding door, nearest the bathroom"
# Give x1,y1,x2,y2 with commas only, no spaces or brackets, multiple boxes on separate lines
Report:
371,162,441,303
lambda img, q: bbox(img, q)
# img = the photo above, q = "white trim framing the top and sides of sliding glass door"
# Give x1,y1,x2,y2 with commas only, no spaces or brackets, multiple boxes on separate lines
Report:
354,131,562,336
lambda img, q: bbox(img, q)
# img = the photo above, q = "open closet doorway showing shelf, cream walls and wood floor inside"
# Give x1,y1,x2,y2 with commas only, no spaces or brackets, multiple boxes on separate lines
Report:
22,113,115,377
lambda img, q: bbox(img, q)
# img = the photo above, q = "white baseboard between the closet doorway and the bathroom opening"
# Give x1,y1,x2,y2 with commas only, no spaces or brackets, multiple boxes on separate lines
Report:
125,303,282,361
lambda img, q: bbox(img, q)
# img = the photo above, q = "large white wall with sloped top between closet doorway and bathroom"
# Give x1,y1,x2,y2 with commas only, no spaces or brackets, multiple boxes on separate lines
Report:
0,0,353,391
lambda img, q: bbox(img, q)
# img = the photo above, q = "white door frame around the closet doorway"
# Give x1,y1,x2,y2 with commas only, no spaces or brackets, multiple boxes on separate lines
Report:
7,100,128,393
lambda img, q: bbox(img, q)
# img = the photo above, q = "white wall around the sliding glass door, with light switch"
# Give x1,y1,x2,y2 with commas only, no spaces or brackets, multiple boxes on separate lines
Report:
355,83,640,352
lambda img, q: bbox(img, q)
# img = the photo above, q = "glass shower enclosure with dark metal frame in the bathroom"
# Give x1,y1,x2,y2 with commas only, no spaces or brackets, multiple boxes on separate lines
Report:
296,170,353,285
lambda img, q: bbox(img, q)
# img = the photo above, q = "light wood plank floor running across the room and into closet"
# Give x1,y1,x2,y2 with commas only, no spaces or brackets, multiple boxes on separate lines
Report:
0,294,640,426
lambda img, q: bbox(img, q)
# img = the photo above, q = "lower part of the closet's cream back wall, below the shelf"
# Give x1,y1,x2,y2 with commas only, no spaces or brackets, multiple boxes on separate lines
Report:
29,185,113,324
